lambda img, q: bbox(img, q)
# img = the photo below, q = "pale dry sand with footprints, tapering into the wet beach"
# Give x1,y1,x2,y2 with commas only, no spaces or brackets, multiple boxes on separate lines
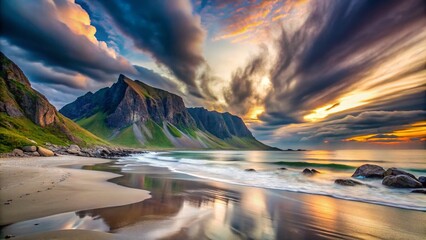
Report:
0,155,150,226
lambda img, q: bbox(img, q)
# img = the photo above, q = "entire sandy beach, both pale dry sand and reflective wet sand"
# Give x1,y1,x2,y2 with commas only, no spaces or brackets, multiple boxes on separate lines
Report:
0,156,426,240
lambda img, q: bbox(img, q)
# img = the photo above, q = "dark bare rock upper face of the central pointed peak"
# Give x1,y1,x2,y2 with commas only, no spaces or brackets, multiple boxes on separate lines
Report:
60,75,195,128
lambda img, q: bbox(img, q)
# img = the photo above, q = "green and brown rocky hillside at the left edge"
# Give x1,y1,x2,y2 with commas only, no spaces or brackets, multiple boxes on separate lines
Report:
0,52,107,152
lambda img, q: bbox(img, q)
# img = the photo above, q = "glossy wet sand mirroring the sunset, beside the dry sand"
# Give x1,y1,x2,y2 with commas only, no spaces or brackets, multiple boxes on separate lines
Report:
2,160,426,239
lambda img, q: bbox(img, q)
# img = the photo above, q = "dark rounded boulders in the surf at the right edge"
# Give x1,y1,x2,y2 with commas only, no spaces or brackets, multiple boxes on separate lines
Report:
335,164,426,193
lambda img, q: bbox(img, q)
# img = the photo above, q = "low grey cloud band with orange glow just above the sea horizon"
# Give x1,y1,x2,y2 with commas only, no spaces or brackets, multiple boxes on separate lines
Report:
264,110,426,147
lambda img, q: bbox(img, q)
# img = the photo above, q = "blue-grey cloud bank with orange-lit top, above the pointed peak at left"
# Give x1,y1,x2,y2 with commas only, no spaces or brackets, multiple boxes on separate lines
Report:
0,0,195,107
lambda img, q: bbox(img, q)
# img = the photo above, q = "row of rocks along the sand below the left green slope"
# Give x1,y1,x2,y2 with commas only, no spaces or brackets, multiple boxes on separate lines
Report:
9,143,143,158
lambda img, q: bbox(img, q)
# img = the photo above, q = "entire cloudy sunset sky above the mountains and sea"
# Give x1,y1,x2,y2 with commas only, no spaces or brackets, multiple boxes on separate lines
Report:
0,0,426,149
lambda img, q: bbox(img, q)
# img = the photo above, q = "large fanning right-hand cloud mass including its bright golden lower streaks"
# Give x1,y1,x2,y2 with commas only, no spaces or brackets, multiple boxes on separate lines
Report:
223,1,426,147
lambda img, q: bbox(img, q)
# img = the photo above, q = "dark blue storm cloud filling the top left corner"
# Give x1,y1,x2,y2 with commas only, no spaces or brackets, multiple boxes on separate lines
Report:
0,0,134,81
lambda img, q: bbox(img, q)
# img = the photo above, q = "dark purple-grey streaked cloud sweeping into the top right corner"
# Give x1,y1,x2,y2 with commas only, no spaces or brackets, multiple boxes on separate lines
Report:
264,1,426,120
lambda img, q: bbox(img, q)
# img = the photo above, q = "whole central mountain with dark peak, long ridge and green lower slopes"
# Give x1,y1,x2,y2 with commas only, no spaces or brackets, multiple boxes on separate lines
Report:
59,75,271,149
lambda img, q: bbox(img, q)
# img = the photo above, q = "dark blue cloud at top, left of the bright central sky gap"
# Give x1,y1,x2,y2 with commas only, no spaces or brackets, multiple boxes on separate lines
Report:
95,0,205,97
